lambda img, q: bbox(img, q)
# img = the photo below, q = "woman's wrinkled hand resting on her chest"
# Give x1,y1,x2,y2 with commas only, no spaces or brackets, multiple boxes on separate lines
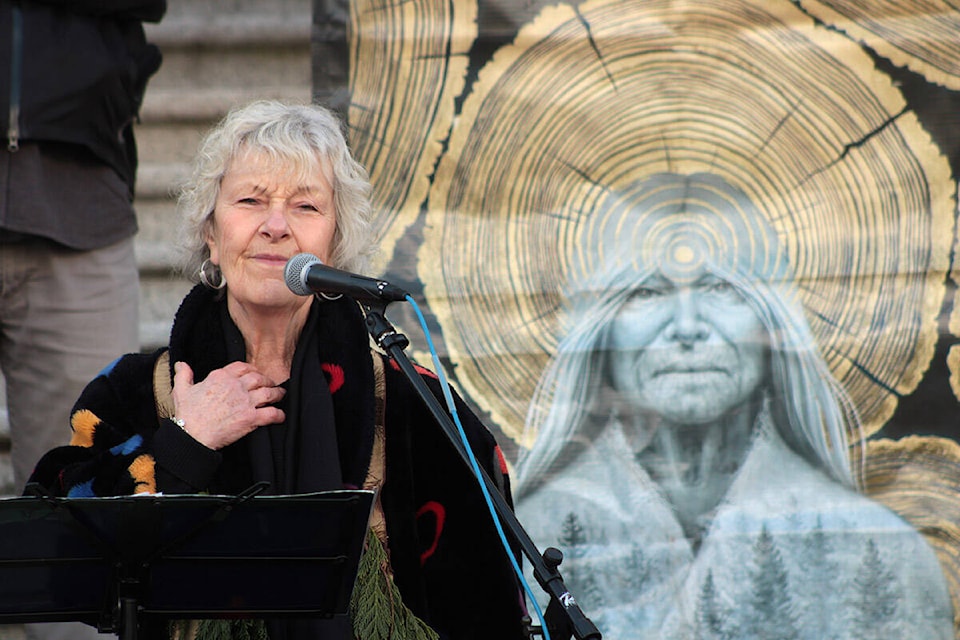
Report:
173,362,286,449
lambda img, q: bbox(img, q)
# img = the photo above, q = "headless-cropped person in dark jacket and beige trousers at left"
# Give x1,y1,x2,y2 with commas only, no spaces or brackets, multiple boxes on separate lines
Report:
0,0,166,640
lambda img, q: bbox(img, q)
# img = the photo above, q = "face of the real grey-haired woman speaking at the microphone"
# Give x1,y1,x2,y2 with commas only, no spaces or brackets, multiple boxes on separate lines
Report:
206,146,337,316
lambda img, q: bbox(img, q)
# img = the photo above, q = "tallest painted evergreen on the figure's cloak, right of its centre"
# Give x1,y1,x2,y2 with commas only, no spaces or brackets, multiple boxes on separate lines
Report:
742,525,800,640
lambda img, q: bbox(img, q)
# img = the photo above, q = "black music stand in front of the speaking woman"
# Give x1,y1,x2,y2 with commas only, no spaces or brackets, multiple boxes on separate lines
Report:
0,484,373,640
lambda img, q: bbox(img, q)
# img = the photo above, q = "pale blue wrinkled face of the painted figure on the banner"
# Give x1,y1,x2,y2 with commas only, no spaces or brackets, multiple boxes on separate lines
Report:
608,273,767,425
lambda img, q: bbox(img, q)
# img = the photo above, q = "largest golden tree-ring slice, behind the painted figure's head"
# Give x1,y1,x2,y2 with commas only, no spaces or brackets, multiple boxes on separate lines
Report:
418,0,953,445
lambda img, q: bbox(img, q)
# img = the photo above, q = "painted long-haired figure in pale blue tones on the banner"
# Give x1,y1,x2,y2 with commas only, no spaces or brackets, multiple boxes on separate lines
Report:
516,173,953,640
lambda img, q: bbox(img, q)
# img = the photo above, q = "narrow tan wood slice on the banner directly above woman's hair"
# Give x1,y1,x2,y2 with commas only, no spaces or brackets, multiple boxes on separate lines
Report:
348,0,477,267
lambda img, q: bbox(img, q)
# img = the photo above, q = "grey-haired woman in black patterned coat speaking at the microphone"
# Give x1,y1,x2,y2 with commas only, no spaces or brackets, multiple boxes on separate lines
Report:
32,102,522,640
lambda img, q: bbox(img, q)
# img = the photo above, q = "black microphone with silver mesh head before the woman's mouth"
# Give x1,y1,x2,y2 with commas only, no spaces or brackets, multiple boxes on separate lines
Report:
283,253,407,302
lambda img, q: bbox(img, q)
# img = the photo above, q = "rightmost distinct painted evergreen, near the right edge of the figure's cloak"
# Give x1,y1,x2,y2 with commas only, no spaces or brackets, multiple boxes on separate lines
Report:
847,538,899,640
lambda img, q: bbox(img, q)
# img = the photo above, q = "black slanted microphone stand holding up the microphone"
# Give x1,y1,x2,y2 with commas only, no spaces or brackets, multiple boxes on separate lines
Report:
362,300,601,640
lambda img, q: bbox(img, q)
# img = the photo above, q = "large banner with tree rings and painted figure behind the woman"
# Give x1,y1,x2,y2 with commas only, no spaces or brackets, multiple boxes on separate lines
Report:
313,0,960,639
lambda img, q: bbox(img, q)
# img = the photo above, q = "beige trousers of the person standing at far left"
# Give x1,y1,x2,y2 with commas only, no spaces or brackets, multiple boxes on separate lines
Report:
0,239,140,640
